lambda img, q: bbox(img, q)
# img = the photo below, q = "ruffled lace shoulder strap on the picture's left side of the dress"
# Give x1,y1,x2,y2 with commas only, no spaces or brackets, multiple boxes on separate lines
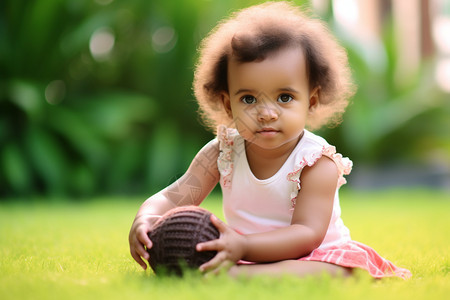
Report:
217,125,239,187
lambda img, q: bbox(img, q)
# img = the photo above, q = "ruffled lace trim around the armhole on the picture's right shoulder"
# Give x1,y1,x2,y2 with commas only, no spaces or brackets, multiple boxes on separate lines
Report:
287,146,353,208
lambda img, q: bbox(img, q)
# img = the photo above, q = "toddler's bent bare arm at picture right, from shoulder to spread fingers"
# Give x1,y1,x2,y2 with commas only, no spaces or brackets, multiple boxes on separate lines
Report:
197,157,338,270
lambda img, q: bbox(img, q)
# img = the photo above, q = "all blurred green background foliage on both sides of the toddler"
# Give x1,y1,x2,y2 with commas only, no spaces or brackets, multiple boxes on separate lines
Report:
0,0,450,197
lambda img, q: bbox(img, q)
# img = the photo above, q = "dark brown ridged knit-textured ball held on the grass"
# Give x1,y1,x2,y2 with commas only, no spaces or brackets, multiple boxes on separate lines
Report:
148,206,220,275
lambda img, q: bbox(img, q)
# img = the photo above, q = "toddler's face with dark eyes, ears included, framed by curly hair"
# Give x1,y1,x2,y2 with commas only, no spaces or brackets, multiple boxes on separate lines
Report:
224,48,318,150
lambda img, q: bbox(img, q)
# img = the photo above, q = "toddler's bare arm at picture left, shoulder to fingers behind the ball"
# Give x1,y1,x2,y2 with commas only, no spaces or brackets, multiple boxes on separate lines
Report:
128,141,219,270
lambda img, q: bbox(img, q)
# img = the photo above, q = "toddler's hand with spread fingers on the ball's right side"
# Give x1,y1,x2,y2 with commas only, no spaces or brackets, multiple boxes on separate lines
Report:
197,215,246,273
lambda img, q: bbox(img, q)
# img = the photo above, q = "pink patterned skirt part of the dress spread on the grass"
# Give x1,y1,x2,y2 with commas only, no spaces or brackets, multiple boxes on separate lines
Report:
299,241,411,279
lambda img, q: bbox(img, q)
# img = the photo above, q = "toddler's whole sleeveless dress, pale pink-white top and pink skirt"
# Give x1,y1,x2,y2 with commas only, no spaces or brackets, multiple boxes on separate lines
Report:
217,126,411,278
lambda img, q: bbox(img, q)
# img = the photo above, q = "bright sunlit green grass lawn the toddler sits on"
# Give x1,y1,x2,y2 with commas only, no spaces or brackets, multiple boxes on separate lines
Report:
0,190,450,300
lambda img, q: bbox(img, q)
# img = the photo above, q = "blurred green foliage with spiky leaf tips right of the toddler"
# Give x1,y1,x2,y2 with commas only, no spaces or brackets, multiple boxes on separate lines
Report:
321,10,450,168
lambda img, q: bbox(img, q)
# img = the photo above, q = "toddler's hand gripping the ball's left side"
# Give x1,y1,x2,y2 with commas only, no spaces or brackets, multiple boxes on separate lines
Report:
128,215,160,270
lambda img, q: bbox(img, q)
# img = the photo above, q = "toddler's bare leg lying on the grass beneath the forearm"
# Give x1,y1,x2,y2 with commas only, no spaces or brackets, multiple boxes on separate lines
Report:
229,260,352,277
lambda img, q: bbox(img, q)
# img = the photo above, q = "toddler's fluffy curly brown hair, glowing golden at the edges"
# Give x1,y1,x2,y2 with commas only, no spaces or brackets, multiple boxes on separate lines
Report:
193,1,355,132
